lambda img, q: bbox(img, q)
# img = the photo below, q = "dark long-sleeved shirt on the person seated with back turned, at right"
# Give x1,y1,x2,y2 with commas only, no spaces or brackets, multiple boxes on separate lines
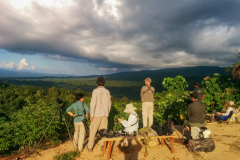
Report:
188,100,207,123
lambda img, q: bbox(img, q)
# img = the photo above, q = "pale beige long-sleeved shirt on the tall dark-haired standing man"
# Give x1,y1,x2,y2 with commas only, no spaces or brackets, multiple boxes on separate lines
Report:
90,86,111,117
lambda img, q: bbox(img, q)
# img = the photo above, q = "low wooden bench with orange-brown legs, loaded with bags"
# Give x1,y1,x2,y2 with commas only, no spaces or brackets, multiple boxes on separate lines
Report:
102,135,176,160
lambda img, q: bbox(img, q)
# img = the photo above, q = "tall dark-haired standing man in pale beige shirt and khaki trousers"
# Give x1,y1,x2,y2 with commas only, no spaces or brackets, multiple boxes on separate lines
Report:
88,77,111,152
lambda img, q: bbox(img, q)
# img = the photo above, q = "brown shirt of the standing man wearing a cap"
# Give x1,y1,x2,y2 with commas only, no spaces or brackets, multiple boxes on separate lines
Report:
140,86,155,102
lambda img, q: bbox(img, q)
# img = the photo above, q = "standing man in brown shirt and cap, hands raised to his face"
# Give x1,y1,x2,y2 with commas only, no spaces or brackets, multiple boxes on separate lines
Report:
140,78,155,127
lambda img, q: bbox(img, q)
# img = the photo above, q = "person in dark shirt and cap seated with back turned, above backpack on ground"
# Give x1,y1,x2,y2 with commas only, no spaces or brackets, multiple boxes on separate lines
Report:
184,93,207,131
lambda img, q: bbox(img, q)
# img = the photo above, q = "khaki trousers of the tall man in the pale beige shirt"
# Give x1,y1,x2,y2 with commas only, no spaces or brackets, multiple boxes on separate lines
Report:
88,116,108,149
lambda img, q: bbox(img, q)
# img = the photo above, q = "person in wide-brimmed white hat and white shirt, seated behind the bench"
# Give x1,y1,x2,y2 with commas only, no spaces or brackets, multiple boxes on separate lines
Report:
118,103,138,134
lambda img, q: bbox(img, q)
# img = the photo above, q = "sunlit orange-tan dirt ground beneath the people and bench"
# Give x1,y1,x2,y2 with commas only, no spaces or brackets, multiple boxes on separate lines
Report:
2,123,240,160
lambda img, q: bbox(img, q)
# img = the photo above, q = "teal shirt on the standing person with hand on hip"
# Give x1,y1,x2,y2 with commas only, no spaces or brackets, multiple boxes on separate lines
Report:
66,101,89,122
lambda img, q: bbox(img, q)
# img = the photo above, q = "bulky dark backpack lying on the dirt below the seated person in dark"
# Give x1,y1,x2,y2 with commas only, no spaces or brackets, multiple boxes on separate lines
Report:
187,138,215,152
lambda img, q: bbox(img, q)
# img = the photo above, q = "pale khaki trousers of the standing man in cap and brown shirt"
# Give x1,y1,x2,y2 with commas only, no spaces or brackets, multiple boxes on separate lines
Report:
142,102,153,127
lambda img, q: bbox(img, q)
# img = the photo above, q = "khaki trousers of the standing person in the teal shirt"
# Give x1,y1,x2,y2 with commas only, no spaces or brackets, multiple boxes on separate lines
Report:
73,122,85,151
